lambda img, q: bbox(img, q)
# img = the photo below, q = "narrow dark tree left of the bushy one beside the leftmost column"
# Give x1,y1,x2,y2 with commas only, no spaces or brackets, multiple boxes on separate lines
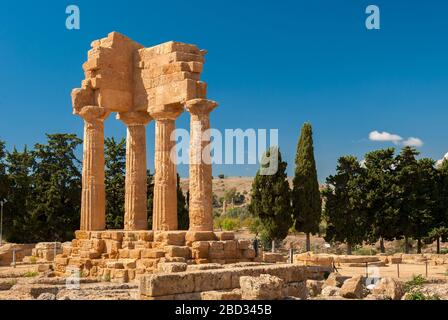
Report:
3,147,36,243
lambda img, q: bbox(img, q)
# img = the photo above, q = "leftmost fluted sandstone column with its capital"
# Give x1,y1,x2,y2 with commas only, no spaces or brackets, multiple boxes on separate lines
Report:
78,106,109,231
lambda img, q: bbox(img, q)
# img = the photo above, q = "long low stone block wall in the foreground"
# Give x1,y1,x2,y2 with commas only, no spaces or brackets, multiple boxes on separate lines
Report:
139,264,330,300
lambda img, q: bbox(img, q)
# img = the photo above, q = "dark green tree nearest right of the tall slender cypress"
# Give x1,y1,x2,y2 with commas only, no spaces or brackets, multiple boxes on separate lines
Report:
323,156,369,254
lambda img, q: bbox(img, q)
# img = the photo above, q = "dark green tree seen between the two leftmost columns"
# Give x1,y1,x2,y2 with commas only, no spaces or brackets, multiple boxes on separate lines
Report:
104,138,126,229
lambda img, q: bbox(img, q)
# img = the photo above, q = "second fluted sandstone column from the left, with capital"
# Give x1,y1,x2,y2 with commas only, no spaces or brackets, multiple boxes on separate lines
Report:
117,112,151,230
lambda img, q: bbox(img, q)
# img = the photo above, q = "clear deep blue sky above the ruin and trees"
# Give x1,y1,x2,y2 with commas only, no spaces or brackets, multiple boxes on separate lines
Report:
0,0,448,181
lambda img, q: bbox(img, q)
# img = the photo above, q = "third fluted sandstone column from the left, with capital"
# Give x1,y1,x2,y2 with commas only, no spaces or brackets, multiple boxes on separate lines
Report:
151,111,181,230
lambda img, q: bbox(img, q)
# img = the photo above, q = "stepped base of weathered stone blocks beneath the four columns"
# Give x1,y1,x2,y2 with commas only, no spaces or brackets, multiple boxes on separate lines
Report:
55,230,262,283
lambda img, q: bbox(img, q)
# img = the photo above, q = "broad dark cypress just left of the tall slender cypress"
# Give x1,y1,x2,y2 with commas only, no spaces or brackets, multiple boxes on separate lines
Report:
249,147,292,245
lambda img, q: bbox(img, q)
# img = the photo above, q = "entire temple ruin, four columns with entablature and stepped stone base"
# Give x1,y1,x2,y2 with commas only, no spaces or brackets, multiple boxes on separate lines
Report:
55,32,264,282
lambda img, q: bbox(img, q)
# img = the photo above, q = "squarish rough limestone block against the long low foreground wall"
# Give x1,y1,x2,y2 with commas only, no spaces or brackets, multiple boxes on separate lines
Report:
240,274,284,300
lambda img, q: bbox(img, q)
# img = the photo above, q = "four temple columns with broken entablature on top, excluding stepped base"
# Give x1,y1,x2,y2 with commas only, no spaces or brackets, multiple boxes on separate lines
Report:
72,32,217,231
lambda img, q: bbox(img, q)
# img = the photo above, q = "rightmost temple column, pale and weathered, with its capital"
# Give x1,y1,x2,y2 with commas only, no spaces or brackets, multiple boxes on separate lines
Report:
187,99,217,231
